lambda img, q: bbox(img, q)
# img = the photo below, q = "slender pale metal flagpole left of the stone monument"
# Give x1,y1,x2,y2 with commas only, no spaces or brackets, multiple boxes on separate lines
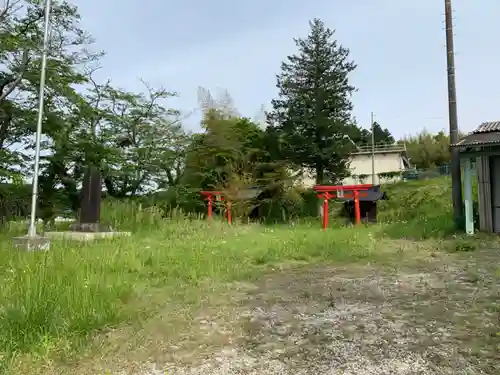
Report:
28,0,51,237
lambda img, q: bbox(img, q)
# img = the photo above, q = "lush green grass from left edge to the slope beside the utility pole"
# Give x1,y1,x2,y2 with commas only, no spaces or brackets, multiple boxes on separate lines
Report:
0,178,486,374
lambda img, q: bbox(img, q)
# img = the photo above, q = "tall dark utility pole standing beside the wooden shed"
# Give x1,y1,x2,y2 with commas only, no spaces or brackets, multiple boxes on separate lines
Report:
444,0,463,227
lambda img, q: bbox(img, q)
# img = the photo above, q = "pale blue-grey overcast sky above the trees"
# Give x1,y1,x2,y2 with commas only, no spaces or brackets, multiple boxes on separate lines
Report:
73,0,500,137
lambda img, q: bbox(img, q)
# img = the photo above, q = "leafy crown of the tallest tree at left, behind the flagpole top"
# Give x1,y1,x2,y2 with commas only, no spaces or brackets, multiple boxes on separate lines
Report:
0,0,98,181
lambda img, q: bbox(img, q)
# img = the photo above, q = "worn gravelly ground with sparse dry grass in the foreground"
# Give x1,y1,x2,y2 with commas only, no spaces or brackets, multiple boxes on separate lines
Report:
22,245,500,375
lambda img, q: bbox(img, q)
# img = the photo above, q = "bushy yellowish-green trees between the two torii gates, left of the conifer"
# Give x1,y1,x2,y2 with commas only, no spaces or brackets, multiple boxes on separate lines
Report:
177,108,308,221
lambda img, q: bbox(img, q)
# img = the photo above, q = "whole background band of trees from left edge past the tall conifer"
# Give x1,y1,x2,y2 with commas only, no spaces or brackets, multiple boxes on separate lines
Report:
0,5,449,225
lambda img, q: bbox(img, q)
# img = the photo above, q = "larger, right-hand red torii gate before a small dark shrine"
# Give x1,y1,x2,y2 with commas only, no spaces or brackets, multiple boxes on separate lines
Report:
313,184,373,230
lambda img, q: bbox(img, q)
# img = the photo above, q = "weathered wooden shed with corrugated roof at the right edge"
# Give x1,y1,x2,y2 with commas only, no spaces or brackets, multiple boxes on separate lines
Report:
451,121,500,234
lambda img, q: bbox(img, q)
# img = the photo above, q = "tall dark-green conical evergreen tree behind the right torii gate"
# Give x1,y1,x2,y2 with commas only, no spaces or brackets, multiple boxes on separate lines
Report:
268,19,356,183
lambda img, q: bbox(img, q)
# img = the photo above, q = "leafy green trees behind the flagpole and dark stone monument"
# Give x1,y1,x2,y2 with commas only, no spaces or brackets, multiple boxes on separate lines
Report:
0,0,190,218
